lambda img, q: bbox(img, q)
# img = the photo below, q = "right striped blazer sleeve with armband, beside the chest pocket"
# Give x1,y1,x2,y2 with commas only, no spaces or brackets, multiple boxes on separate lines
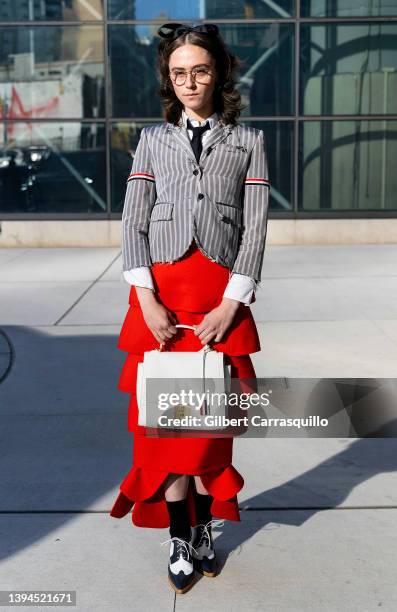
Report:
232,130,270,290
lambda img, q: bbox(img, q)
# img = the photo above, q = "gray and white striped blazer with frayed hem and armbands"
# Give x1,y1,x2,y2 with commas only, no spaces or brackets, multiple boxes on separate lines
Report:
122,120,270,286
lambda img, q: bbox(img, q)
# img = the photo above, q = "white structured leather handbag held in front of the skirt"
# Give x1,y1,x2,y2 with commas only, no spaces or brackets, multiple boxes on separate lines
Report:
136,323,231,430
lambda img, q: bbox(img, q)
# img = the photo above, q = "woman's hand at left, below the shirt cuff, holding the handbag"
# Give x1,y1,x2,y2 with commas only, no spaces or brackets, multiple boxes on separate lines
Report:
136,287,178,342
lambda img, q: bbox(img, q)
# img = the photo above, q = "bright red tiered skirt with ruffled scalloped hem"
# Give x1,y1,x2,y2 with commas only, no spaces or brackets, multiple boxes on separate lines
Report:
110,242,261,528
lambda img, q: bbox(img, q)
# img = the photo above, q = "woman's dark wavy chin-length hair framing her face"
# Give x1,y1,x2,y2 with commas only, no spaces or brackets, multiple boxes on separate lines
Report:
156,26,245,125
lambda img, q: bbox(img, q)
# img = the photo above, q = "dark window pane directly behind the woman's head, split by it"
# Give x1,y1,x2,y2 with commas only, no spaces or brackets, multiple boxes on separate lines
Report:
109,24,294,117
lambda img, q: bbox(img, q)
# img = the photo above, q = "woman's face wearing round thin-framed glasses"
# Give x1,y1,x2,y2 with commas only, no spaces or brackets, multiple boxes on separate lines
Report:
168,43,216,113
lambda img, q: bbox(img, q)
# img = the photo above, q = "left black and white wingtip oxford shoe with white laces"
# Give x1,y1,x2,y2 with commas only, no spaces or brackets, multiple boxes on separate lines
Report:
161,529,195,594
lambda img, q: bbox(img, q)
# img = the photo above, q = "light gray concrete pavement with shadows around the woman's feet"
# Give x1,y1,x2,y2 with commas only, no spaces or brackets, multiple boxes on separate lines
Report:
0,244,397,612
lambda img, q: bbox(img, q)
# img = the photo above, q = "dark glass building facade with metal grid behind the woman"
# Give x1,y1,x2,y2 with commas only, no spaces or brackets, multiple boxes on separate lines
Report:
0,0,397,219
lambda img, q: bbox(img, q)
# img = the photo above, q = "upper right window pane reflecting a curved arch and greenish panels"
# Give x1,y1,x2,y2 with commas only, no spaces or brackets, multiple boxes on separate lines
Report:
300,23,397,115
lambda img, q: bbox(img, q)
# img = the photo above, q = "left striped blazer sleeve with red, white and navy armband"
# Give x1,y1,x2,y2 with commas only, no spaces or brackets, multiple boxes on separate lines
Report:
121,128,156,270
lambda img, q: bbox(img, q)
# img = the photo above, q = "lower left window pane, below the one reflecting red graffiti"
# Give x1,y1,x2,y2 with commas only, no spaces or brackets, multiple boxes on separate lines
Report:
0,122,106,213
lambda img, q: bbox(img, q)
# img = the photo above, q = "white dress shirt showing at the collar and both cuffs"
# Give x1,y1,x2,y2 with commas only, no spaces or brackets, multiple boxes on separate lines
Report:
122,110,255,306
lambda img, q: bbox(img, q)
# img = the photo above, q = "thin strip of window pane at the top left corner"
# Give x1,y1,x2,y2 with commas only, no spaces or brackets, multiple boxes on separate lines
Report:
0,0,103,21
